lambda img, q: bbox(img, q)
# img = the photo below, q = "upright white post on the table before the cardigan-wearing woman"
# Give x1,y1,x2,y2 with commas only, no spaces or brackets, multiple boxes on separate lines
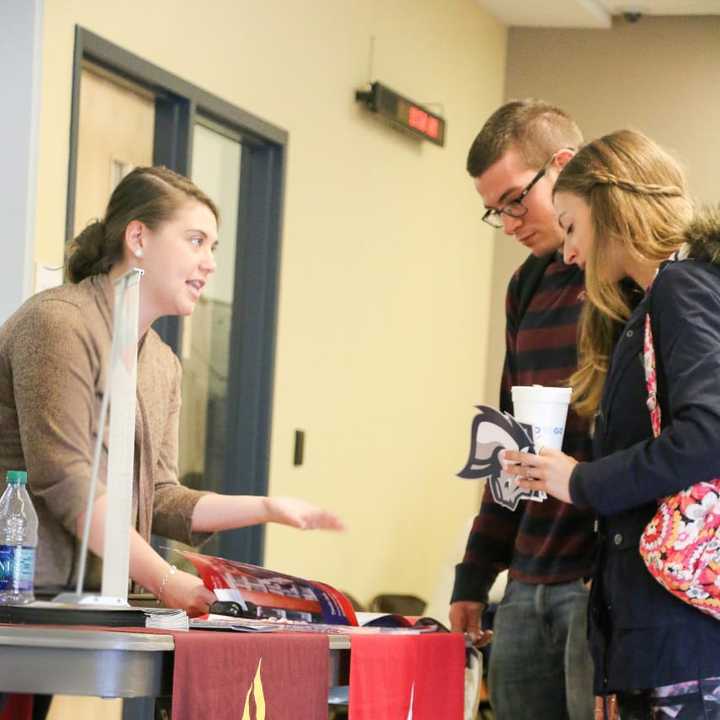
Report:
102,269,142,603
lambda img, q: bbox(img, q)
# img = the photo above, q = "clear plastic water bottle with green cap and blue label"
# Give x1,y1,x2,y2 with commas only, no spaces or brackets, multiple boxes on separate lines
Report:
0,470,38,605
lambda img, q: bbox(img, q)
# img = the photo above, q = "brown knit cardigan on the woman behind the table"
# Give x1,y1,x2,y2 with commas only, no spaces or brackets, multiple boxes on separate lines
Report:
0,275,207,587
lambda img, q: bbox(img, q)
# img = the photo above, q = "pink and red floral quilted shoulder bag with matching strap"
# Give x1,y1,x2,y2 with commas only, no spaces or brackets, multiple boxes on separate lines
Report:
640,314,720,620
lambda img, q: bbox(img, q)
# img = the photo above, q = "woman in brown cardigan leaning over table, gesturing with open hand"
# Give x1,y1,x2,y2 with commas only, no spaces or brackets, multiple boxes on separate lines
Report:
0,168,341,614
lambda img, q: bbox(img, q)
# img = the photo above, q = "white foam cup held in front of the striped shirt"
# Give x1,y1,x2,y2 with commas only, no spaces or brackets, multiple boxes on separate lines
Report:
512,385,572,452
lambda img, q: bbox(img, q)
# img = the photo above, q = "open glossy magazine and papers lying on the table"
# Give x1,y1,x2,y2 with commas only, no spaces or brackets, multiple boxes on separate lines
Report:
181,550,446,634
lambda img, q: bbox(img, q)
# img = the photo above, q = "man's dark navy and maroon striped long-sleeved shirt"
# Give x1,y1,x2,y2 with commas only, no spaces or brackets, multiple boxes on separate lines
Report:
452,255,594,603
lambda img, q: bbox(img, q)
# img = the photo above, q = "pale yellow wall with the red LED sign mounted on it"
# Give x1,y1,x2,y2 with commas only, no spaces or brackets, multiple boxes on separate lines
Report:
36,0,506,612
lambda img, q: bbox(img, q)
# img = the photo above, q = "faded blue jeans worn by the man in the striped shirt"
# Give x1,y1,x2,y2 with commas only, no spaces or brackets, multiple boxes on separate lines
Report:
488,580,594,720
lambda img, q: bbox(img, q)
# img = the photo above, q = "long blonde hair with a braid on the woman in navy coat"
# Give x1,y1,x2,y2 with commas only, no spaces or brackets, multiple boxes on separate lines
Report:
554,130,692,417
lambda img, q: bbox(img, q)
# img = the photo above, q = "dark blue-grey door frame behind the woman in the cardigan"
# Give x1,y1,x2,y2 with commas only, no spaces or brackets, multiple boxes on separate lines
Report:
65,26,288,564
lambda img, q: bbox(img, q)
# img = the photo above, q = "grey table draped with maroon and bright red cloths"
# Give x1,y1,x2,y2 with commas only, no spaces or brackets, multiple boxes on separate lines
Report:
0,625,465,720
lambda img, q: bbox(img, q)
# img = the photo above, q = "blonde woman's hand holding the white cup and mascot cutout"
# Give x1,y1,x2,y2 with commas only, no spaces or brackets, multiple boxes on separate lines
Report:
500,448,577,503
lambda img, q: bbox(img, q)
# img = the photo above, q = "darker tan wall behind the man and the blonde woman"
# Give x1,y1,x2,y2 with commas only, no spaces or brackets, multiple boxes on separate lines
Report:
487,17,720,404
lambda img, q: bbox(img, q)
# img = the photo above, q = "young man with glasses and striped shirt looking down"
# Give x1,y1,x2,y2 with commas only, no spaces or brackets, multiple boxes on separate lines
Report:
450,100,594,720
